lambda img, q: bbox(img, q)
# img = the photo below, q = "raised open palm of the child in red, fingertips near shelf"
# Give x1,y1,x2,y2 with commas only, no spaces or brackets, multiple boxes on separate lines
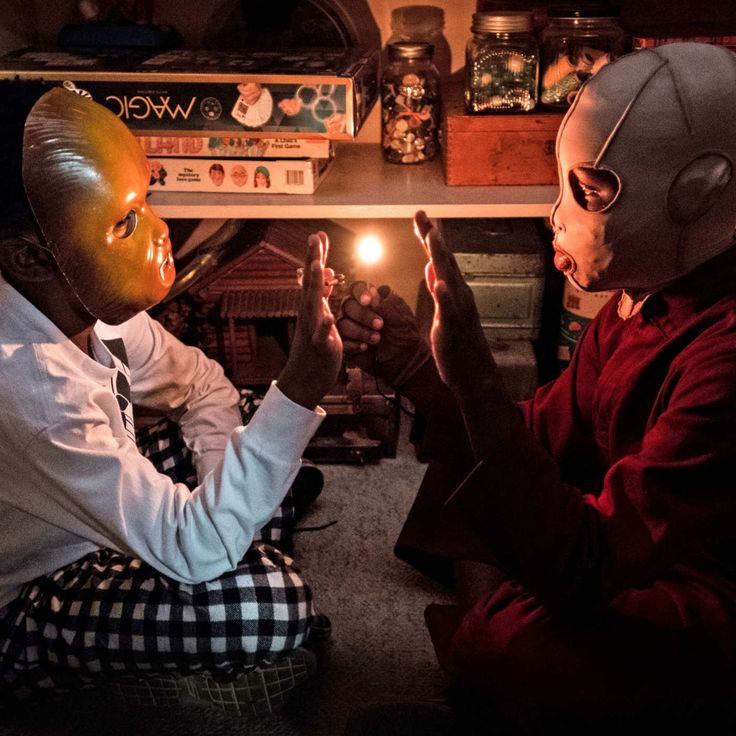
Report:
414,211,495,396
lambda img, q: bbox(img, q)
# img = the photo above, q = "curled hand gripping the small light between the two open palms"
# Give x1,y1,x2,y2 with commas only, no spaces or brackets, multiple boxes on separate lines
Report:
337,281,431,389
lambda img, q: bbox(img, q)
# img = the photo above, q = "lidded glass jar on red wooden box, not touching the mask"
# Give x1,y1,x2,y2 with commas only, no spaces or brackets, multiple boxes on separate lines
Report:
465,10,539,114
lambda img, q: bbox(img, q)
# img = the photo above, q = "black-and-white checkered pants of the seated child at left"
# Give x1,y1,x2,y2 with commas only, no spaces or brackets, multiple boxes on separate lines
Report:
0,392,315,700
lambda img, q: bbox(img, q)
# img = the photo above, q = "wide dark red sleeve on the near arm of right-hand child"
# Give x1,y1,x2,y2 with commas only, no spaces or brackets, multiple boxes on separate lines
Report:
445,330,736,611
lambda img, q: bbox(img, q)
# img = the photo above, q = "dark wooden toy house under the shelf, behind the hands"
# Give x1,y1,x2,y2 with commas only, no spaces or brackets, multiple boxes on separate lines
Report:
150,220,399,462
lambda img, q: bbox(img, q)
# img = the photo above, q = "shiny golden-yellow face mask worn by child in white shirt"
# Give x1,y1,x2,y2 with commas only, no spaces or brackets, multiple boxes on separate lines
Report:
23,87,175,324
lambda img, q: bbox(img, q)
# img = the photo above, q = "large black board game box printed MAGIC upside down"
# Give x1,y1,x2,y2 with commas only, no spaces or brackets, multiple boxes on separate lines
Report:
0,48,379,140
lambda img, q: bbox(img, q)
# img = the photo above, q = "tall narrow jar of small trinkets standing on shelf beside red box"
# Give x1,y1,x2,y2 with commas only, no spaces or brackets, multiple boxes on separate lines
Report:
381,41,440,164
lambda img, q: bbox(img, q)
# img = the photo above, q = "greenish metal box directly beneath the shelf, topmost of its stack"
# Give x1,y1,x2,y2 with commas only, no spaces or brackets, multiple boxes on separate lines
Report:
440,218,545,340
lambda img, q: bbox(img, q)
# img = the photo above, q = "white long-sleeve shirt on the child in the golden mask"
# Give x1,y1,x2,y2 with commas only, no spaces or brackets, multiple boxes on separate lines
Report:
0,277,324,606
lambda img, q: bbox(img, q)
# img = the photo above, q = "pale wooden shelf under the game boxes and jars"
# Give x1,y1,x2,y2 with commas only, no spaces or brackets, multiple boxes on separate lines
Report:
149,142,557,219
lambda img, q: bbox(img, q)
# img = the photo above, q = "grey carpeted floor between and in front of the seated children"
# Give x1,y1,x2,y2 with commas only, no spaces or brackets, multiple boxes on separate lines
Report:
0,418,449,736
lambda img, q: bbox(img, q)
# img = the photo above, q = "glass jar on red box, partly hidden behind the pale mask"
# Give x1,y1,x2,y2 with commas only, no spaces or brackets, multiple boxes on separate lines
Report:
540,5,625,110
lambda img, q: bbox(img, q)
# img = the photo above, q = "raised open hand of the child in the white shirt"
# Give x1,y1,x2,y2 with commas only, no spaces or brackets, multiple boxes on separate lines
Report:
277,232,342,409
